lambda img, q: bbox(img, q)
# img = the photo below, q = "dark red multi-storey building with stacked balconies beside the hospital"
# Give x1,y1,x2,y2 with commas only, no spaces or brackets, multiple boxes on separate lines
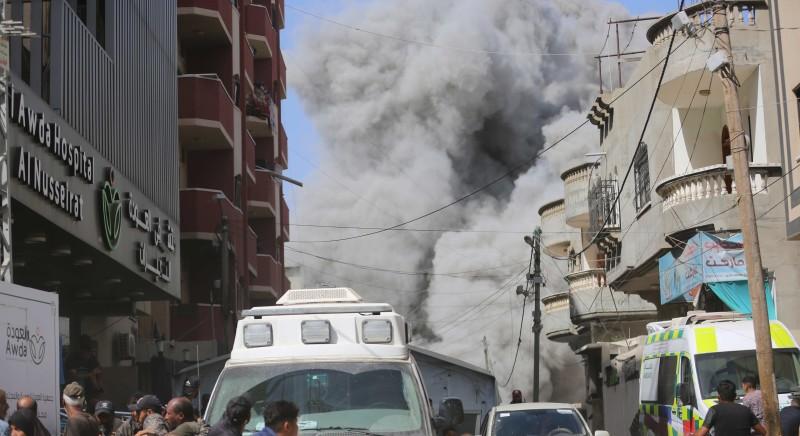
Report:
171,0,289,360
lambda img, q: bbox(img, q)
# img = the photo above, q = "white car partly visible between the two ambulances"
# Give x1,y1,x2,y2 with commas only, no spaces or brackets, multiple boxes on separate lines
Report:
480,403,610,436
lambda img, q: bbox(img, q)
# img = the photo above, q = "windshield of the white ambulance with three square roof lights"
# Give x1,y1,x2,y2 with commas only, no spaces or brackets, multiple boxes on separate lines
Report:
207,362,425,435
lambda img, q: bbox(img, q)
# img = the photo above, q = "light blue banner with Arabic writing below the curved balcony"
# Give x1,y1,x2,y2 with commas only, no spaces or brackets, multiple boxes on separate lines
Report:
658,232,747,304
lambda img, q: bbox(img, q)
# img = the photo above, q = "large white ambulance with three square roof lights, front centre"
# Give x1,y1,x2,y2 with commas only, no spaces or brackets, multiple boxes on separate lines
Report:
205,288,463,435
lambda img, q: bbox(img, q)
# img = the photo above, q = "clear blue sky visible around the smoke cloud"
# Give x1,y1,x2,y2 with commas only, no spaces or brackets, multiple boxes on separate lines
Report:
281,0,680,211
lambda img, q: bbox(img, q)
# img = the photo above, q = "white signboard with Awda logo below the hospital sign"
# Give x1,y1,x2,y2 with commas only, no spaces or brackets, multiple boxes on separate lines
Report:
0,283,60,435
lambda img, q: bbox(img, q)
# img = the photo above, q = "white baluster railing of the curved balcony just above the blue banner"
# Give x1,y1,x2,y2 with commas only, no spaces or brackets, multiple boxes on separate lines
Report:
656,164,781,211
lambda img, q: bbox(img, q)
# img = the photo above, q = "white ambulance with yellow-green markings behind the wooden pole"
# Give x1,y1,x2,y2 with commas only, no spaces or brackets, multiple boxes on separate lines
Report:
639,312,800,435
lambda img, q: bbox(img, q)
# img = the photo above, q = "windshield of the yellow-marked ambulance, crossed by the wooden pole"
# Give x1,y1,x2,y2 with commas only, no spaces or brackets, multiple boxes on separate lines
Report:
695,350,800,399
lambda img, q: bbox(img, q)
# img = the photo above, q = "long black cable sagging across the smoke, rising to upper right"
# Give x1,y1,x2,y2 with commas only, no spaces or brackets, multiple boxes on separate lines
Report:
290,34,689,243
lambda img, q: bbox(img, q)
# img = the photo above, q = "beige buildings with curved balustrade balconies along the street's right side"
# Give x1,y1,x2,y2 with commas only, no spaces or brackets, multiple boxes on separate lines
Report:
539,0,800,428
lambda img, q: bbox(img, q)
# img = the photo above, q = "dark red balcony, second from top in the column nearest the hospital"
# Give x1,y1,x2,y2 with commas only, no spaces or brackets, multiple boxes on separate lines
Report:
178,74,234,150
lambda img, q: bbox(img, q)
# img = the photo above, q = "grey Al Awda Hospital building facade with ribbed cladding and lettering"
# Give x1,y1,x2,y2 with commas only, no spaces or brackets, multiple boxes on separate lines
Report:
4,0,181,408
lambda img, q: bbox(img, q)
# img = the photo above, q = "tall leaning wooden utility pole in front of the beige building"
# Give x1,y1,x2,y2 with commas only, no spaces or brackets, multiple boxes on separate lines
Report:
712,5,780,436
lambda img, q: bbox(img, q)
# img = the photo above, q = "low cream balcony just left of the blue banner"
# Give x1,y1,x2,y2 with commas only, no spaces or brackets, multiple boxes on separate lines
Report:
565,269,657,325
